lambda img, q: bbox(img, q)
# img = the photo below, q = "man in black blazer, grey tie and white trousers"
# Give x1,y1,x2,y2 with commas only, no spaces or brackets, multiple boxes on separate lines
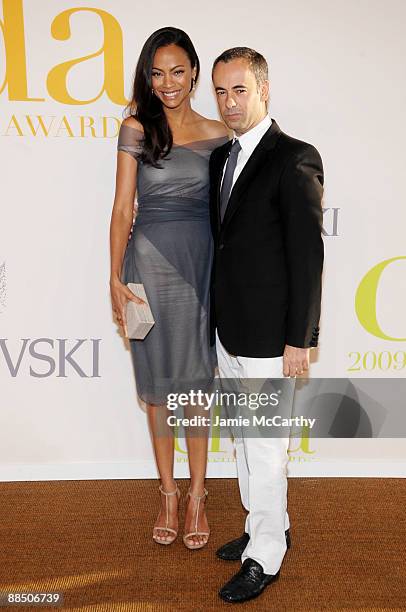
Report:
210,47,324,602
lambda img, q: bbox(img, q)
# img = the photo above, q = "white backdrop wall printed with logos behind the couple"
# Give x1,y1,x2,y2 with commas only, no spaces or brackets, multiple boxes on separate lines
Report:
0,0,406,480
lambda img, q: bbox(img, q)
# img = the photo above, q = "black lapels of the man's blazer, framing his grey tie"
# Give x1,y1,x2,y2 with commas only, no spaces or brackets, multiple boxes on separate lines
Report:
217,119,281,230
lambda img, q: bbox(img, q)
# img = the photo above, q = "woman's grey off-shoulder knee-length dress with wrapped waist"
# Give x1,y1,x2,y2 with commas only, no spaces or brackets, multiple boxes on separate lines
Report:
117,124,227,405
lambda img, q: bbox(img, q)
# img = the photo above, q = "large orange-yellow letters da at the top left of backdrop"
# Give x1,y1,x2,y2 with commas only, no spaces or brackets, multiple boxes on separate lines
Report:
0,0,128,105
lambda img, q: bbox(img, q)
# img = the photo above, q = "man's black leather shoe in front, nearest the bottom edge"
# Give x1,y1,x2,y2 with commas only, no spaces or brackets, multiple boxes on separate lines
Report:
219,559,279,603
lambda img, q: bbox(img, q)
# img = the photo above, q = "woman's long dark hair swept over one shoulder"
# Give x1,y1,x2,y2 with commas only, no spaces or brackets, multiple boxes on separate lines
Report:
126,27,200,168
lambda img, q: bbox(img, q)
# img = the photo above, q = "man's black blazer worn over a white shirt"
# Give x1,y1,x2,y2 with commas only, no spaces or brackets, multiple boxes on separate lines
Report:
210,120,324,357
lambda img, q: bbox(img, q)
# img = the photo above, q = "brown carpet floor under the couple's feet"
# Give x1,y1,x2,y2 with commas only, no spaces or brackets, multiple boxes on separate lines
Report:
0,478,406,612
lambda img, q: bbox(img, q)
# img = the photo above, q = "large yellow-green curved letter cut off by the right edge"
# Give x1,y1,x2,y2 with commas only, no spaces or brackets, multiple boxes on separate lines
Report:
355,256,406,342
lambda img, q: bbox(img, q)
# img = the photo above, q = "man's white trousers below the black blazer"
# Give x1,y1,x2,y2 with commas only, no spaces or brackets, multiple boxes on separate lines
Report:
216,332,294,574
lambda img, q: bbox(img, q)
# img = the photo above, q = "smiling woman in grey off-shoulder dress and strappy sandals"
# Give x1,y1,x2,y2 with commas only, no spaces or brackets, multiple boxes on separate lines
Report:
110,27,228,549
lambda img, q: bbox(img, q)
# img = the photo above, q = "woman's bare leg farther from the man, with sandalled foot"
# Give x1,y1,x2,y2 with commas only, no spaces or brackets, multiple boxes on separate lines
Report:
147,404,178,541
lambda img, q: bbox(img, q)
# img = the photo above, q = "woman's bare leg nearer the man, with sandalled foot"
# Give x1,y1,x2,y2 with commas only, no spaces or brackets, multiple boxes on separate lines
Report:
184,406,210,545
